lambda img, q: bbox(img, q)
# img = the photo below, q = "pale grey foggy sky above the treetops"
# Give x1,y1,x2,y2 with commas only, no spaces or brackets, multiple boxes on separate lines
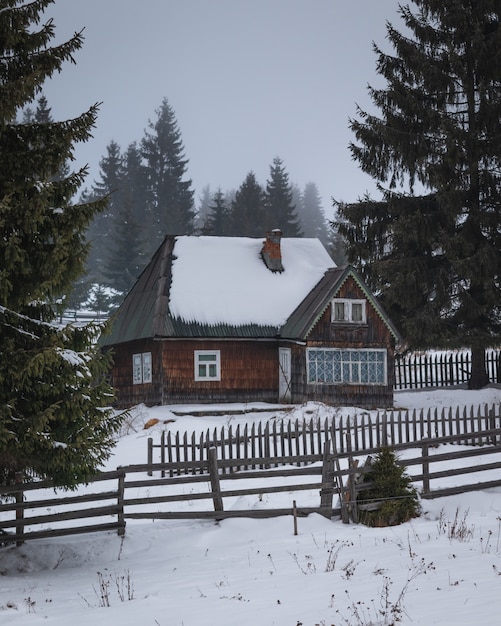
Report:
44,0,401,217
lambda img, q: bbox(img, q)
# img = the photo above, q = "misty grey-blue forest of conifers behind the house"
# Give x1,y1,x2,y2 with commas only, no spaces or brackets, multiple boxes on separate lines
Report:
23,95,346,314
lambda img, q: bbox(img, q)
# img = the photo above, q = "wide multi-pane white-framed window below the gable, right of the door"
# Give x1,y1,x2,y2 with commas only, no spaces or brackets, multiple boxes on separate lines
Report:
307,348,387,385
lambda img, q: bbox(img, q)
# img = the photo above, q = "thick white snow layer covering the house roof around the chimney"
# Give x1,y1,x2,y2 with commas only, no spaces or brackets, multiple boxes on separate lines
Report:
169,236,336,327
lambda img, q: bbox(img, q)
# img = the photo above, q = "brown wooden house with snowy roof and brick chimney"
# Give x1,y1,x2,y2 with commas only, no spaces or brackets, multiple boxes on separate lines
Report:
101,230,399,407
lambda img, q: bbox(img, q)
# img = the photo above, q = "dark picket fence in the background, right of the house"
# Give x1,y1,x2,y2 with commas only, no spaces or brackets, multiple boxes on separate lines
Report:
395,350,501,390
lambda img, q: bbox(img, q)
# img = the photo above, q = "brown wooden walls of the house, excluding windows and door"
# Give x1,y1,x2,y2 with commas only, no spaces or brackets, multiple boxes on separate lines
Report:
108,276,395,408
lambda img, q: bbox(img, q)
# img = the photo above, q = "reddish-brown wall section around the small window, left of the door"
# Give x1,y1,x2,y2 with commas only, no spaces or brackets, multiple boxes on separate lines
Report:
161,340,278,404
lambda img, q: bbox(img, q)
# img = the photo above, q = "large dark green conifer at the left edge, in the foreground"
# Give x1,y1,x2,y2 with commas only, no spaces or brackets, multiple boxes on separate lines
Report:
0,0,120,487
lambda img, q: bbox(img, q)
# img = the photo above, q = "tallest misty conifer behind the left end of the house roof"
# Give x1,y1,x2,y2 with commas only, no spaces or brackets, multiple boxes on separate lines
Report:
141,98,195,251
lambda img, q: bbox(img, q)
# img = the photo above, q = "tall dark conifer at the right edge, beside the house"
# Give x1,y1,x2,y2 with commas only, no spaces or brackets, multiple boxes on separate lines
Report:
340,0,501,388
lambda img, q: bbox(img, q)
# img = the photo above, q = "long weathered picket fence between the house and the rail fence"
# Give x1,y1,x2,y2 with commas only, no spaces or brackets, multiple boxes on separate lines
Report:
147,404,501,475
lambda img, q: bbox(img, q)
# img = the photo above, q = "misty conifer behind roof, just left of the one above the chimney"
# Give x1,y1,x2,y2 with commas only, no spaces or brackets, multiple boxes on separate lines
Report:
230,172,268,237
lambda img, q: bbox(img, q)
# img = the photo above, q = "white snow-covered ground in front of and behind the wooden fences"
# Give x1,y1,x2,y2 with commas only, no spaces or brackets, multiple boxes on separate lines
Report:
0,387,501,626
